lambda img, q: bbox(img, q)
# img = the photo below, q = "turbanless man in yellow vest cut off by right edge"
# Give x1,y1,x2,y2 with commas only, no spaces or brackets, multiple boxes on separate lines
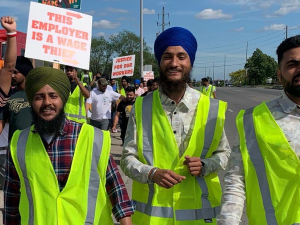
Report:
218,35,300,225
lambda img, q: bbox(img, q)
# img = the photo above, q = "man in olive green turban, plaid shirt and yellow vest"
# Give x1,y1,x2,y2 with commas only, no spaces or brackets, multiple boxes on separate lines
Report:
4,67,134,225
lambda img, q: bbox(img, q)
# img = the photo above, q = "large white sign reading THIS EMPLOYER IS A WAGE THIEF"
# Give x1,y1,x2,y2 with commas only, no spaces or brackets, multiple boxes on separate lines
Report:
25,2,93,70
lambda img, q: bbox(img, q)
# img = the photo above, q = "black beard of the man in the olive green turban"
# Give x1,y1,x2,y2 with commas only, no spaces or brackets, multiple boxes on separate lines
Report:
32,109,66,136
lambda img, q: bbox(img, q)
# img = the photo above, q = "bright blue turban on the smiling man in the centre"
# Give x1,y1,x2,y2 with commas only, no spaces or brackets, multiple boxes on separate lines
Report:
154,27,197,66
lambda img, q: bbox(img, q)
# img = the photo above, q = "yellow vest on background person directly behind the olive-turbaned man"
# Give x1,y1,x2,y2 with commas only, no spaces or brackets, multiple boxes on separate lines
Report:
65,83,86,123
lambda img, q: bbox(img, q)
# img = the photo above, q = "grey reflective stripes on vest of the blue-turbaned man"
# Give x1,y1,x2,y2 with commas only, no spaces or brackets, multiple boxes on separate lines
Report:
135,92,220,221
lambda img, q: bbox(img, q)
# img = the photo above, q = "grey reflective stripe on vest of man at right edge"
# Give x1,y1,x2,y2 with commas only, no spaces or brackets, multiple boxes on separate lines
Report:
243,108,277,225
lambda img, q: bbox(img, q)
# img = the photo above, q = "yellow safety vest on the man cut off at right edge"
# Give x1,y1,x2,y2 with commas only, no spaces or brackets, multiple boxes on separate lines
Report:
236,103,300,225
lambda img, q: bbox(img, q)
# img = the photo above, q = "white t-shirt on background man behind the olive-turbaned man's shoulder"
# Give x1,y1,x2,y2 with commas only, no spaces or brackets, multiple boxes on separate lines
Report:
86,90,120,120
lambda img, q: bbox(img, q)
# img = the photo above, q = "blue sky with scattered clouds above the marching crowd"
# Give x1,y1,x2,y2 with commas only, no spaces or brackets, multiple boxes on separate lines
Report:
0,0,300,80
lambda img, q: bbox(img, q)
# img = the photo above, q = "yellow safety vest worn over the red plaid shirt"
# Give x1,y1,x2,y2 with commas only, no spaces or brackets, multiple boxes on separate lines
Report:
11,124,113,225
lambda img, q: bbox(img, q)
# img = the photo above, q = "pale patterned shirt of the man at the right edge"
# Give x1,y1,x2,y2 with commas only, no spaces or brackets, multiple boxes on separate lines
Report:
217,91,300,225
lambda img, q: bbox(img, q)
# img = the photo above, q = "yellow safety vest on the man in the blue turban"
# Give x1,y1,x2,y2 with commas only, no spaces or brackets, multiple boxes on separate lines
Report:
132,91,227,225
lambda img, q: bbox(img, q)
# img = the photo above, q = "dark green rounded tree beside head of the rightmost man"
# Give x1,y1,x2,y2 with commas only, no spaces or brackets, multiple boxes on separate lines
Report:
245,48,277,85
